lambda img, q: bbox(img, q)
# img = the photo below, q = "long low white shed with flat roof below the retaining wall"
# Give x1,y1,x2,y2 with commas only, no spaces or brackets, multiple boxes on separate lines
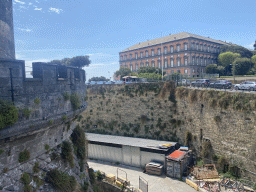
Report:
86,133,178,167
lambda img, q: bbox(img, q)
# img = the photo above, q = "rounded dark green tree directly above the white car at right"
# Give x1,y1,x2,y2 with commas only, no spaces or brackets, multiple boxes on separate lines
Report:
234,58,254,75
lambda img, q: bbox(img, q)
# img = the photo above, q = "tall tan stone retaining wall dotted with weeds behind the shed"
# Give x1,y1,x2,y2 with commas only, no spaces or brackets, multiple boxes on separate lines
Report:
80,83,256,182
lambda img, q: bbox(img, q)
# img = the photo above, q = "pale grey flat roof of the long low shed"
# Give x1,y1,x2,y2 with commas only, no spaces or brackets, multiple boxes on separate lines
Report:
85,133,177,150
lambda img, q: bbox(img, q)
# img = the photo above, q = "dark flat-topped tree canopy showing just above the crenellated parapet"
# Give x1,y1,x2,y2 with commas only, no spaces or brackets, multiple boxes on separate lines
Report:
49,55,91,68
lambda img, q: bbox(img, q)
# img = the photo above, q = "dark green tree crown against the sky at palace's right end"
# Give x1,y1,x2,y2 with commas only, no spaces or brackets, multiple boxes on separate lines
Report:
220,45,253,58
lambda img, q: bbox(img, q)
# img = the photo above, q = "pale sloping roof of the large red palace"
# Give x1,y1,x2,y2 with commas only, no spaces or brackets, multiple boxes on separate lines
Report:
121,32,229,52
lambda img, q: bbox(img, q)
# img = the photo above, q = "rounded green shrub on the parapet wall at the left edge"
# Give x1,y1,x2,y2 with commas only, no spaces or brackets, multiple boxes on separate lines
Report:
0,99,19,129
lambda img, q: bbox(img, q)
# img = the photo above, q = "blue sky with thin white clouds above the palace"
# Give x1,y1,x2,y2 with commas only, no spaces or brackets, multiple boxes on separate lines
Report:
13,0,256,80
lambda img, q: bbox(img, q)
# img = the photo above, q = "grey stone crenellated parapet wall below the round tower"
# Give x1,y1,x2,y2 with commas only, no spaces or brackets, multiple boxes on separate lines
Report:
0,59,86,139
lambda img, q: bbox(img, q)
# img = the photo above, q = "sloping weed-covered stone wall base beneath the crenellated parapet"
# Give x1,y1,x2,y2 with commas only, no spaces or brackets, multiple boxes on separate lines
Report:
0,119,92,191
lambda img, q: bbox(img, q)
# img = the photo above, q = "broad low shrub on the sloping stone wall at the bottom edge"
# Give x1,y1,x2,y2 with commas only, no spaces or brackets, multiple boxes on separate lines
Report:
46,169,76,192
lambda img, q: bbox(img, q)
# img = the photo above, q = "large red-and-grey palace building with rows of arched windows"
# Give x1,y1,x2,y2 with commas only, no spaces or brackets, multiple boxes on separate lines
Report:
119,32,228,77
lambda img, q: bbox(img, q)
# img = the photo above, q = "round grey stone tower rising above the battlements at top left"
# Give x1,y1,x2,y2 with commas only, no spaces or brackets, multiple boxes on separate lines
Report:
0,0,15,59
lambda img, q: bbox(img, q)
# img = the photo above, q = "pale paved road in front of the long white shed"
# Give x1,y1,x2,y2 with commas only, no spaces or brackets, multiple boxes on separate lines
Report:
88,160,196,192
